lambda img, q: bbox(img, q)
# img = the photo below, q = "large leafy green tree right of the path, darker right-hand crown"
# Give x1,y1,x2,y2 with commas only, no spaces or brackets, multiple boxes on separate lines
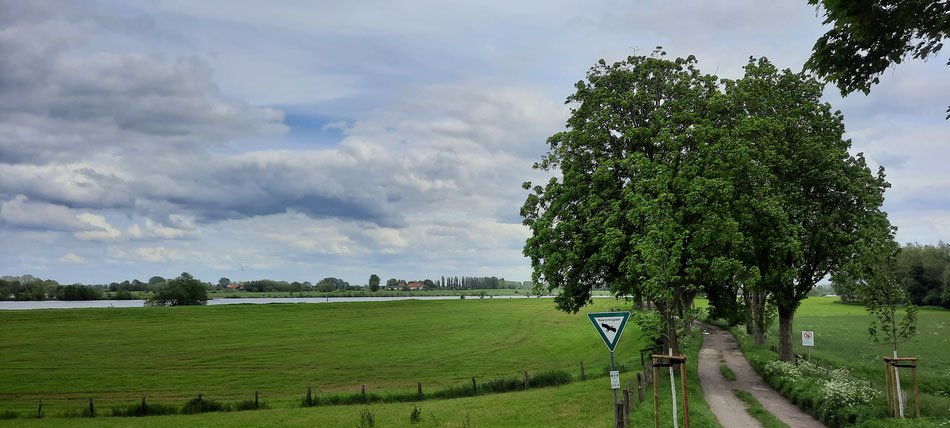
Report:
726,58,890,361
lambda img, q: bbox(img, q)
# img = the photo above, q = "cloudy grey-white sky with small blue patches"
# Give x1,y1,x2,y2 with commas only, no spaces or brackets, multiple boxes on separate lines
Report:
0,0,950,284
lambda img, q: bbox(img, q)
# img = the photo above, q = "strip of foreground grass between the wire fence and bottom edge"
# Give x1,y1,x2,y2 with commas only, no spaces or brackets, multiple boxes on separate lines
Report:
3,326,720,428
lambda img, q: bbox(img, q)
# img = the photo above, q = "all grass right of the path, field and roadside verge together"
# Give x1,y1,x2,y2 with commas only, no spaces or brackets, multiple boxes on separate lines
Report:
733,297,950,427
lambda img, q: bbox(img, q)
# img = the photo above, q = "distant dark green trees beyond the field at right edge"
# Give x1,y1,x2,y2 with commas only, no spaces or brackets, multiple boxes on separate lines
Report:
831,242,950,308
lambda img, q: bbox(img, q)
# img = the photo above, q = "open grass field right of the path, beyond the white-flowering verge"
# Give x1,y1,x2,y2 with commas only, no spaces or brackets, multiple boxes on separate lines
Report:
740,297,950,420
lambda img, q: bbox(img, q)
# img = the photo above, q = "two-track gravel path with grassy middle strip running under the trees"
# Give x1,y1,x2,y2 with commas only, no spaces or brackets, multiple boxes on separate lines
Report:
699,324,824,428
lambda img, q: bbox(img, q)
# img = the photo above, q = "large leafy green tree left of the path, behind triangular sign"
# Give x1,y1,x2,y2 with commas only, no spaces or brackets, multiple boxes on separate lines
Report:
521,50,738,352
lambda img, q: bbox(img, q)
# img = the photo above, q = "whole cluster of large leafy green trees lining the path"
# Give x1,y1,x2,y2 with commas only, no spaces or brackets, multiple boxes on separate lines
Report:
521,49,893,360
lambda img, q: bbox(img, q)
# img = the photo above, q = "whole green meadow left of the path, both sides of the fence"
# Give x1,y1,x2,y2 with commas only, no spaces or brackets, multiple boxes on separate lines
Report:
0,299,711,426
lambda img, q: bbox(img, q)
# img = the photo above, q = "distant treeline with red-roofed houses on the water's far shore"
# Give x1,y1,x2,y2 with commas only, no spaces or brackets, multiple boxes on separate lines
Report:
0,273,531,301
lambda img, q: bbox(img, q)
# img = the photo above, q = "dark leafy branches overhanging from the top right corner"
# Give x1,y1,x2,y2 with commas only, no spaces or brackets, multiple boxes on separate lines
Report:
806,0,950,118
